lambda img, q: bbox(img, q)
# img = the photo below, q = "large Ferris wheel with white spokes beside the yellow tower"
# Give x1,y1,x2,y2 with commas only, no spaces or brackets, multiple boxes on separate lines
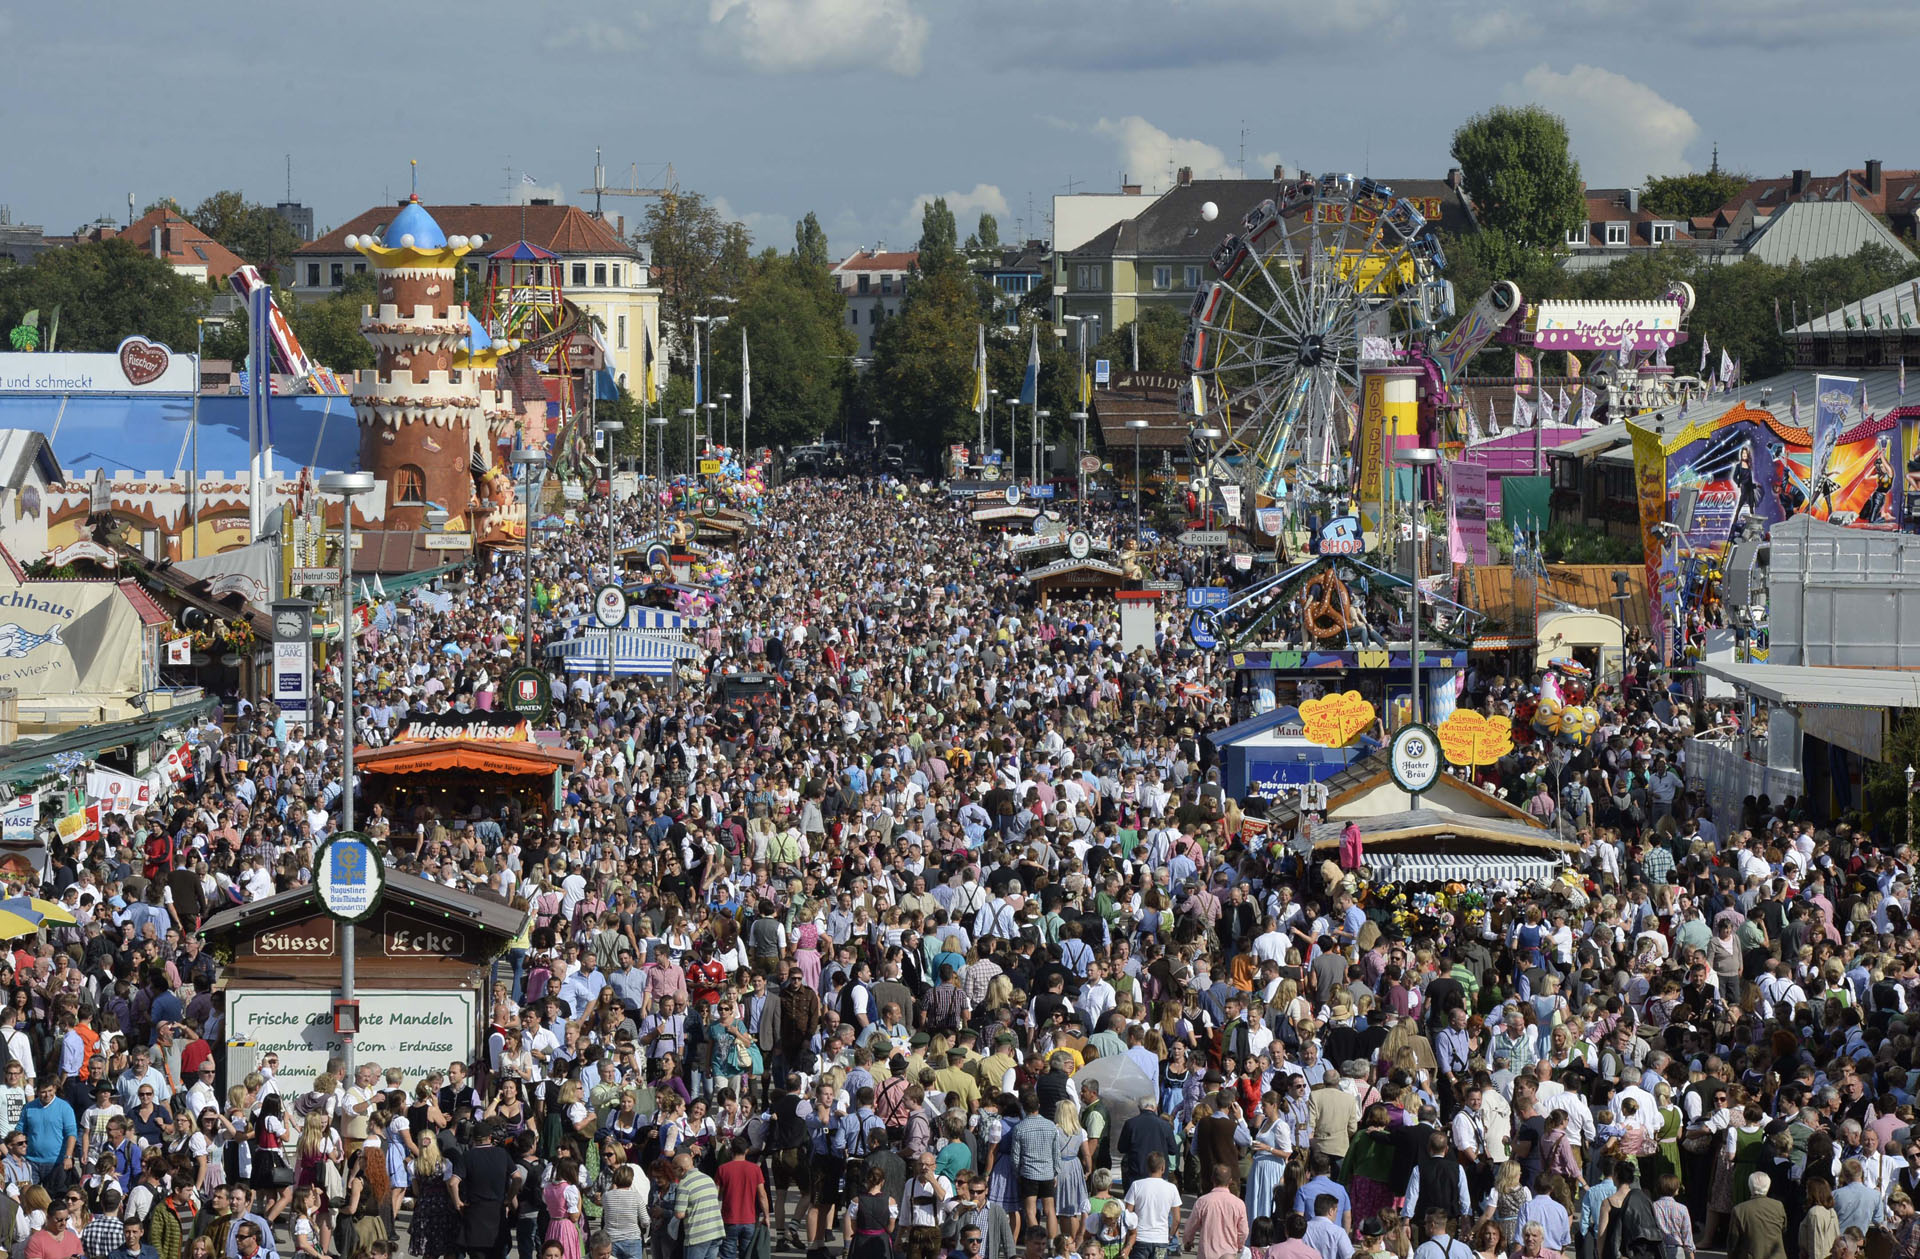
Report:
1183,175,1452,499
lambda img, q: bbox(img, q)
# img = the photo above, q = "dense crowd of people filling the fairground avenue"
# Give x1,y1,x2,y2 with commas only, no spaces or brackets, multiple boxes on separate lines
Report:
0,480,1896,1259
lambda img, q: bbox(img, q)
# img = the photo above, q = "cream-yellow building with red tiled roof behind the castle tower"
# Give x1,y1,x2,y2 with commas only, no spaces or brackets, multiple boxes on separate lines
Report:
284,203,666,393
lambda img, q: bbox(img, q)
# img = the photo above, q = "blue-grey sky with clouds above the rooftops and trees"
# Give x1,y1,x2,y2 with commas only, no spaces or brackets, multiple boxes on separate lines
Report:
0,0,1920,253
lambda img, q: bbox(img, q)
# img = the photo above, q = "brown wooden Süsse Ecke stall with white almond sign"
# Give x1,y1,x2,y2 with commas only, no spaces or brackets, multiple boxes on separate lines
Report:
202,873,528,1090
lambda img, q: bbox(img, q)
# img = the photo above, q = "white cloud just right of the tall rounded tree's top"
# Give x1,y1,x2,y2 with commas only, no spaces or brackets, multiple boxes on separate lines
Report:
1505,65,1699,186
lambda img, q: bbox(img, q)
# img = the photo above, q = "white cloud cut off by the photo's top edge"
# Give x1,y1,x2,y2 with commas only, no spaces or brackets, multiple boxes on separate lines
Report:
707,0,927,75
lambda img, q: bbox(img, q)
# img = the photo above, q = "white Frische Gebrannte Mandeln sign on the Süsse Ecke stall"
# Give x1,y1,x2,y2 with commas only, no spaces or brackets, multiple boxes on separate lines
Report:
227,986,476,1081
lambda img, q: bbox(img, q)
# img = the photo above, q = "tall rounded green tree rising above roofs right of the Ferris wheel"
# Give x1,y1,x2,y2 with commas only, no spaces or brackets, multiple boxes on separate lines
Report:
1452,106,1586,248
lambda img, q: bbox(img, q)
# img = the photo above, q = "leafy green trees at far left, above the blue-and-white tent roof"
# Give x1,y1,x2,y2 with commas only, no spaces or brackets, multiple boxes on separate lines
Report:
0,236,211,353
